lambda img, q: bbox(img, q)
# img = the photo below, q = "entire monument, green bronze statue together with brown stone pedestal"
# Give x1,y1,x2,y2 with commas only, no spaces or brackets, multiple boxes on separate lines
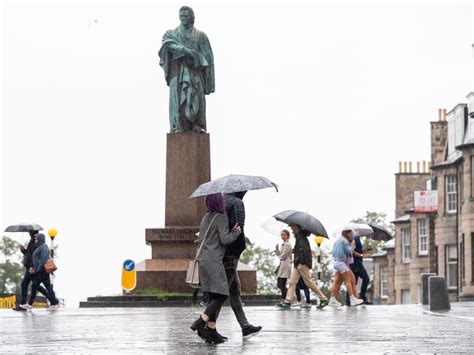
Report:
136,6,257,293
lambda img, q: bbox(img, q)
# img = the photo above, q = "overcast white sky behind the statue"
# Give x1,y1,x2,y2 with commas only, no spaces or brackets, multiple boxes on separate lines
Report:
0,1,473,305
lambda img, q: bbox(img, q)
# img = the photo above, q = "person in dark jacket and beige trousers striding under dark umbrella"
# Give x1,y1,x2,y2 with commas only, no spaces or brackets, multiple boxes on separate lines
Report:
278,224,329,309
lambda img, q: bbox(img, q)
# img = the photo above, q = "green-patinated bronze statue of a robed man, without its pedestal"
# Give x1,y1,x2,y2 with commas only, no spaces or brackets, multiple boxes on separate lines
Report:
158,6,215,133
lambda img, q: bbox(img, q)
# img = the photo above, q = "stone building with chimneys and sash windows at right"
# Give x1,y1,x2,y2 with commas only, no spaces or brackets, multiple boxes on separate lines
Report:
374,93,474,304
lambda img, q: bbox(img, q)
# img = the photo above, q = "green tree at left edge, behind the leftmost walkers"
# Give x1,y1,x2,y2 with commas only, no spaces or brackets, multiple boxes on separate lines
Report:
0,236,24,293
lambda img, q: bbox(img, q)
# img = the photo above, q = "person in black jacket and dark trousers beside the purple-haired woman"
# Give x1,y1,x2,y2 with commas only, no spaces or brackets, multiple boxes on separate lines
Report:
223,191,262,339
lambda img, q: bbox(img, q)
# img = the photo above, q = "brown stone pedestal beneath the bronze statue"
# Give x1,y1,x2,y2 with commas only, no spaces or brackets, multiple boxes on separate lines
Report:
136,133,257,293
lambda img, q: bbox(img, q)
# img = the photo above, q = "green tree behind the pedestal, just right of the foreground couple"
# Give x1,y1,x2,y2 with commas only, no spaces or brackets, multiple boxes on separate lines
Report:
240,245,278,294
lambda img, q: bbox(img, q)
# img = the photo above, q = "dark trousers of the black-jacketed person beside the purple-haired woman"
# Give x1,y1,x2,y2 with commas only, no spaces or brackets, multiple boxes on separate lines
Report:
223,256,250,328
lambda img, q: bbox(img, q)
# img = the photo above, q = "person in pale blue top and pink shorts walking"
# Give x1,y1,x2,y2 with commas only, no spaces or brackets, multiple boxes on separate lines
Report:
329,229,364,307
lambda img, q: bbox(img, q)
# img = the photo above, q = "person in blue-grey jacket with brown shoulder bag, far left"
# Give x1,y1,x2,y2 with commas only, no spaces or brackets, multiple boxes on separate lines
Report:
28,233,58,311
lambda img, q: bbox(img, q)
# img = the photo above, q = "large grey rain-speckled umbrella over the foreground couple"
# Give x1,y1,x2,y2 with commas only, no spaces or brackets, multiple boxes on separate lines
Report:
189,175,278,198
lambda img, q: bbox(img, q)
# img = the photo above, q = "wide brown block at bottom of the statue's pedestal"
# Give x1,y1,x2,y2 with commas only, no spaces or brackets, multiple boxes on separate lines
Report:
136,259,257,293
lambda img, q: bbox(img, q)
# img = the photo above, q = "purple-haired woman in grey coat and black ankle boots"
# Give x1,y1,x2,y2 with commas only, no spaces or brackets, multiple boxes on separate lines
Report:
191,194,241,344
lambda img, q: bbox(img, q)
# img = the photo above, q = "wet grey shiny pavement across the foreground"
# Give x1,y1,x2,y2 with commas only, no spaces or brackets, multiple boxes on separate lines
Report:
0,303,474,354
